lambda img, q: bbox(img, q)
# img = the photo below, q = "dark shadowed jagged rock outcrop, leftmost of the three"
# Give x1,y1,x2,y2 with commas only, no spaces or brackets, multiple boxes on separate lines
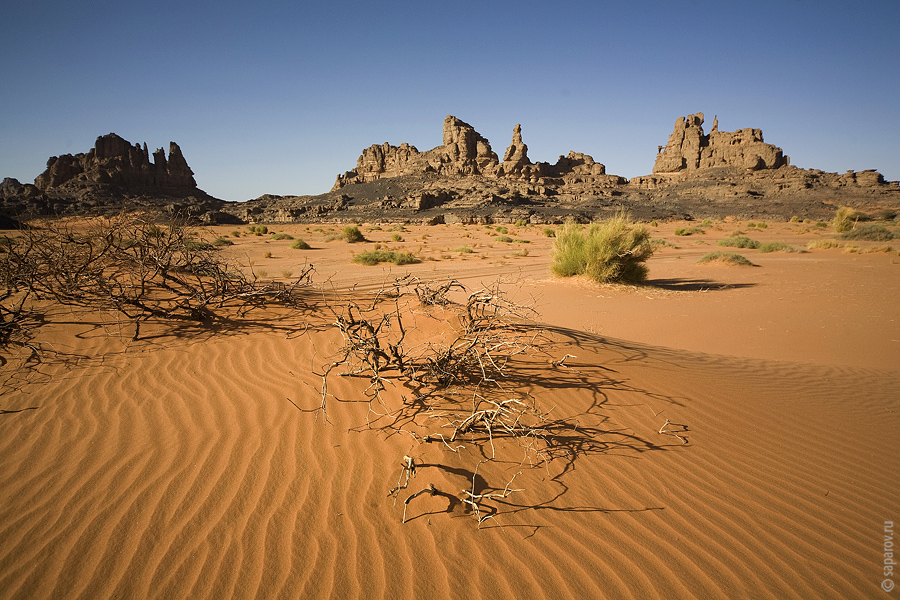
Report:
34,133,197,191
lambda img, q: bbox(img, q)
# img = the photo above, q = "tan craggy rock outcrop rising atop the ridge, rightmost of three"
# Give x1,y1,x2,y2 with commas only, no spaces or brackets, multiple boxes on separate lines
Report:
653,113,790,173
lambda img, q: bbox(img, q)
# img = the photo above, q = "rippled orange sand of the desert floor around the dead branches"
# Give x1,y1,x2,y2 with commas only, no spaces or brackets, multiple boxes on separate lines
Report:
0,222,900,599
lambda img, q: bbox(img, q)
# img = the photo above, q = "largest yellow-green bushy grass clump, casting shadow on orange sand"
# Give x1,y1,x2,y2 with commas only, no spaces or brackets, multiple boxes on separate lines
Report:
550,212,653,283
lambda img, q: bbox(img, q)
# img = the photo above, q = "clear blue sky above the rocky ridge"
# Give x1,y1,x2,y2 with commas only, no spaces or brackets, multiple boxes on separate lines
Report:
0,0,900,200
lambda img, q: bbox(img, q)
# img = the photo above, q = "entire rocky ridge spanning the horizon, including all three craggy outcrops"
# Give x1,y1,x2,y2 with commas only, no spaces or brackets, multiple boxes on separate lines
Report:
0,113,900,223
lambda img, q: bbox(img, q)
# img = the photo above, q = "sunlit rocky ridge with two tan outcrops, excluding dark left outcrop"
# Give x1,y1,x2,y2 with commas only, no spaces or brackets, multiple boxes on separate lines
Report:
230,113,900,223
